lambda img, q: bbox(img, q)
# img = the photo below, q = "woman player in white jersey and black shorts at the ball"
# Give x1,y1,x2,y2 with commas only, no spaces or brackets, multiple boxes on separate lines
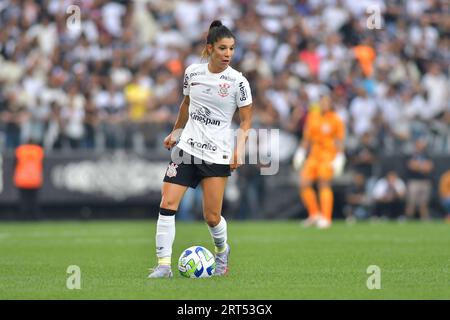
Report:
149,20,252,278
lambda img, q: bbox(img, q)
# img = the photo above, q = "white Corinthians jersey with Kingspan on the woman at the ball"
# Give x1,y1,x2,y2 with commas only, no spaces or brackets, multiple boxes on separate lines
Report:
178,63,252,164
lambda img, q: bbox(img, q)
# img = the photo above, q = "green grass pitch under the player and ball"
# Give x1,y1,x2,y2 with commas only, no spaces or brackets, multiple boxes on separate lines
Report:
0,220,450,300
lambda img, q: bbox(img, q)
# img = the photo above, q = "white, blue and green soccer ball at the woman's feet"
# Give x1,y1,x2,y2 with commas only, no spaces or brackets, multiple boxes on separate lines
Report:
178,246,216,278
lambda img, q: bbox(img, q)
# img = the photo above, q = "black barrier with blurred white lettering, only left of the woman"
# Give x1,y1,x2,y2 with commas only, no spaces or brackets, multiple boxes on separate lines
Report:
0,152,169,205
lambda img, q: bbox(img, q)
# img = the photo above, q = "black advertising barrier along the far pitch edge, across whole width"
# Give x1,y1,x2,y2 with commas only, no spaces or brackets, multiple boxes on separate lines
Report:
0,152,450,219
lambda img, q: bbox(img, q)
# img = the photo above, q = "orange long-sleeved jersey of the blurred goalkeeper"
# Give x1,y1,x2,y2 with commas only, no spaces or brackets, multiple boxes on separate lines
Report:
303,111,345,158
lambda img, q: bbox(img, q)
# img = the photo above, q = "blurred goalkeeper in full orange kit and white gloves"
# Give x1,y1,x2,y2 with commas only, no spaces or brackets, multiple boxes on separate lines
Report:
293,95,345,229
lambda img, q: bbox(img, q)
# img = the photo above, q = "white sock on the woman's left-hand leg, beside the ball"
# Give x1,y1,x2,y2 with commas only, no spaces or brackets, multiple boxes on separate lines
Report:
156,213,175,265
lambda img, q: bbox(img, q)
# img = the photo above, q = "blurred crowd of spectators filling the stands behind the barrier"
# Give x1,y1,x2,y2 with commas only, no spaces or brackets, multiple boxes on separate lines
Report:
0,0,450,217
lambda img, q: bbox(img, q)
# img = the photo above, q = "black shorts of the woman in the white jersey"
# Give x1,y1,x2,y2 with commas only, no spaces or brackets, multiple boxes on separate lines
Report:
164,147,231,189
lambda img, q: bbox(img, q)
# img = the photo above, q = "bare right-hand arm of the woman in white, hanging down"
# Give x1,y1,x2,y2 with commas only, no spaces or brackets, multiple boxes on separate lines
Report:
231,103,253,170
